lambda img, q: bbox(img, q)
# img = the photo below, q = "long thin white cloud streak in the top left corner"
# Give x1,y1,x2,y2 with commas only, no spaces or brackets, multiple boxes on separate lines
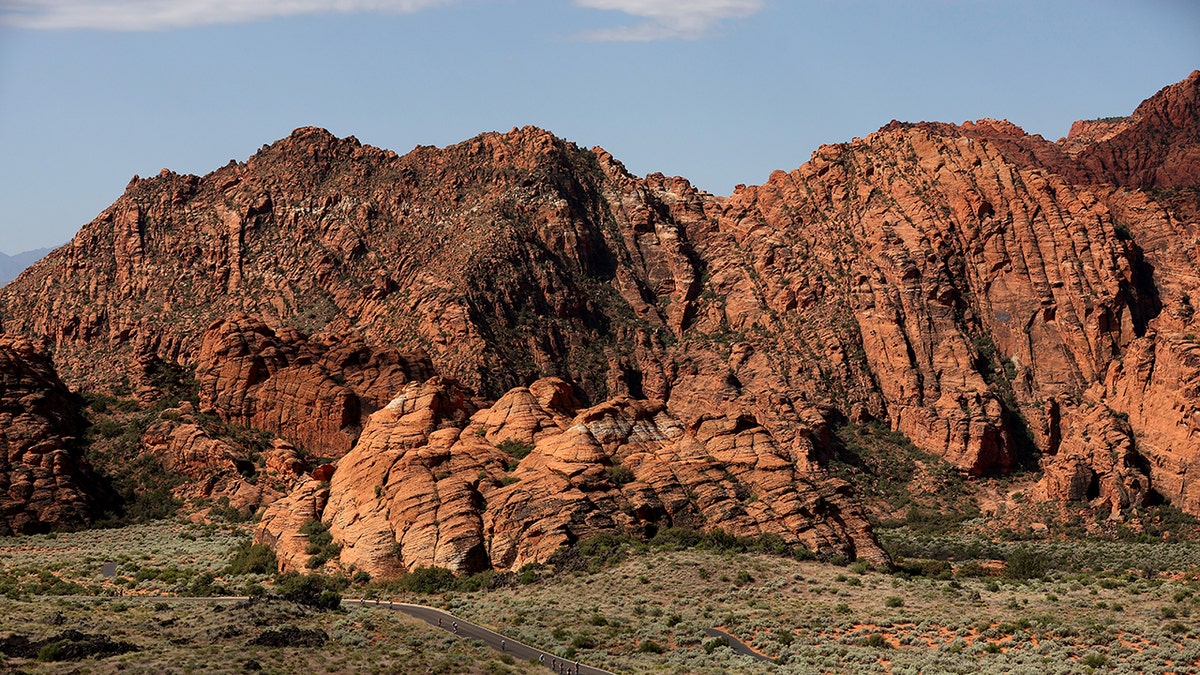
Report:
0,0,454,31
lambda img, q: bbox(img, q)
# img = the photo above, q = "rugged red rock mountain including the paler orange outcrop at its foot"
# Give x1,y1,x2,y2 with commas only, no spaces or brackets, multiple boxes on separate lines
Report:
0,72,1200,571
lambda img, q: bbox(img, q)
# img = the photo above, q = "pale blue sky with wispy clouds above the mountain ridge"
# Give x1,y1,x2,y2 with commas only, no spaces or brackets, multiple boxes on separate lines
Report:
0,0,1200,253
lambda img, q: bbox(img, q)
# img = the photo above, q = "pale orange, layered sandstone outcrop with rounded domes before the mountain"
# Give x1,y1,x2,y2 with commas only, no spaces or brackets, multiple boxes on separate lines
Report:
259,378,887,577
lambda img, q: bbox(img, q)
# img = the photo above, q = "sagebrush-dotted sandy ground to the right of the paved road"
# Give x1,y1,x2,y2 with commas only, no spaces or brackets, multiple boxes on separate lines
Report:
420,544,1200,674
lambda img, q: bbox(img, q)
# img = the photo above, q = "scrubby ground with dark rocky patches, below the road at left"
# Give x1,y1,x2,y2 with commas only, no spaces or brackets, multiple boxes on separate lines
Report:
0,598,534,675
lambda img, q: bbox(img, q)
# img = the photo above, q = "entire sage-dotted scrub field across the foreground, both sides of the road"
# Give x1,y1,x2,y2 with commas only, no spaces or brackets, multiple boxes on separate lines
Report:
0,522,1200,674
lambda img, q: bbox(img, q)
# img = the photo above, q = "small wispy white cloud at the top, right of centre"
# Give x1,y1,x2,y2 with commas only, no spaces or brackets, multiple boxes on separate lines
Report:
575,0,763,42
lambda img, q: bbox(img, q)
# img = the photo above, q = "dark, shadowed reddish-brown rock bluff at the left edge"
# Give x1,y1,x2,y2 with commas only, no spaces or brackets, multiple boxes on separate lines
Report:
0,336,98,534
